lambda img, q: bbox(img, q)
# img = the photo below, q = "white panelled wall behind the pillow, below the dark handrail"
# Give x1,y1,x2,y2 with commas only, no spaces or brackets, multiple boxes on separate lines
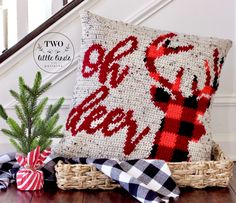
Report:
0,0,236,160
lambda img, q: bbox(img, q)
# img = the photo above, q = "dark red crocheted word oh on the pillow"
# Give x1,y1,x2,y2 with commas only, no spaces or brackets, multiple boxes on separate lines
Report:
82,36,138,88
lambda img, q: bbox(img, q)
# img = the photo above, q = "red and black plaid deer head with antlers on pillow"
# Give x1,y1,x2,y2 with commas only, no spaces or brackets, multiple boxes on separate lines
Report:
145,34,223,161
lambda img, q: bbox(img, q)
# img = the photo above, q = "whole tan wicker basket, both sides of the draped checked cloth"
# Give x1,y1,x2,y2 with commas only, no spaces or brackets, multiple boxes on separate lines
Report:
55,144,233,190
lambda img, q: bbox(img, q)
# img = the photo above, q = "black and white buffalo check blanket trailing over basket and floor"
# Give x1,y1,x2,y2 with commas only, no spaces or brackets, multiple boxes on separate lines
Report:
0,153,180,203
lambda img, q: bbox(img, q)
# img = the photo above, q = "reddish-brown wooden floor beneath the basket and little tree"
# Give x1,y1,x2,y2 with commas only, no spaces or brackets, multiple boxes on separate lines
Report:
0,165,236,203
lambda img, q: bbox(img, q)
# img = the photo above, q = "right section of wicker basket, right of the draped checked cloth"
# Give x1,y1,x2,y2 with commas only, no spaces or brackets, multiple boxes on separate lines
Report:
168,144,234,188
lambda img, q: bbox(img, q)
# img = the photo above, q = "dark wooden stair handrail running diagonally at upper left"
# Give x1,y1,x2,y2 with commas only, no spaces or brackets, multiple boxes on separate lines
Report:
0,0,84,64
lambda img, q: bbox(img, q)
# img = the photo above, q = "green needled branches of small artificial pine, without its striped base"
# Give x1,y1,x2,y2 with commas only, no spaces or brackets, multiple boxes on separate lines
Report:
0,72,64,155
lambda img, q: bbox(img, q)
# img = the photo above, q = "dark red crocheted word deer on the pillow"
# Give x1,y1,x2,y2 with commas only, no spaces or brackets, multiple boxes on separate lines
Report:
66,86,150,155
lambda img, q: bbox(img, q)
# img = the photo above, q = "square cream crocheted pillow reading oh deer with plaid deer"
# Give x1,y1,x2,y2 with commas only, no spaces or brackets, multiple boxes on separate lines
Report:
54,11,231,161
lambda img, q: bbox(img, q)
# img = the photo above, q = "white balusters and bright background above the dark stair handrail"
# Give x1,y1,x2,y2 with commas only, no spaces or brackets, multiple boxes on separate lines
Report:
0,0,72,53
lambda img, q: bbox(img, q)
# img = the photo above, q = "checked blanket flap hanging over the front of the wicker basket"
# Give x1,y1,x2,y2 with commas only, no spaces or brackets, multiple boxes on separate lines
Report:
76,158,179,203
